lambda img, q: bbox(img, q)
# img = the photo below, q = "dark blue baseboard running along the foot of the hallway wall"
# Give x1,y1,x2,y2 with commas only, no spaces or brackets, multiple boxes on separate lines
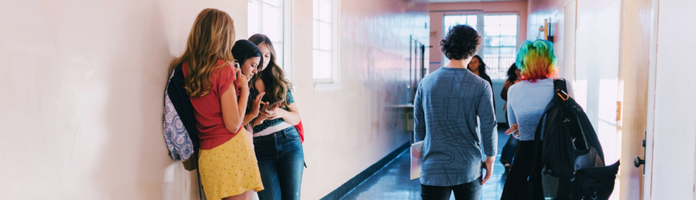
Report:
321,142,410,200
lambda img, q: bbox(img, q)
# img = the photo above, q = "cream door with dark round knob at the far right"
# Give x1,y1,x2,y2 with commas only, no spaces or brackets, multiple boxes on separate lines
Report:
614,0,651,200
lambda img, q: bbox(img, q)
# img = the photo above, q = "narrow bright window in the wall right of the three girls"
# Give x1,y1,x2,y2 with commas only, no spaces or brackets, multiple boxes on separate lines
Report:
312,0,338,84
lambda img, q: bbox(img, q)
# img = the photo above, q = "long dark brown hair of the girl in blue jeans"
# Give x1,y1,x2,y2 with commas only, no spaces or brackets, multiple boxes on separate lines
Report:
249,33,292,108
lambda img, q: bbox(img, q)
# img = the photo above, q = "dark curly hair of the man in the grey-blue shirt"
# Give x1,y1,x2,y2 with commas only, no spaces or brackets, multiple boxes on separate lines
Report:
440,25,481,60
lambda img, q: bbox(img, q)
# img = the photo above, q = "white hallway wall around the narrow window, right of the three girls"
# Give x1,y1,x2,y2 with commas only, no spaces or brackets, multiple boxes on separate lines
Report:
293,0,429,199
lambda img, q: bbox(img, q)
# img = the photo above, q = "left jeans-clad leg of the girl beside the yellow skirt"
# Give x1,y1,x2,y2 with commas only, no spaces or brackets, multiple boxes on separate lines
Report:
254,143,280,200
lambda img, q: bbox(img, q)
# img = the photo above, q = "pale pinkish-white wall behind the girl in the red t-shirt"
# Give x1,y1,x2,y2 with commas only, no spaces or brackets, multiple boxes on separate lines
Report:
0,0,247,199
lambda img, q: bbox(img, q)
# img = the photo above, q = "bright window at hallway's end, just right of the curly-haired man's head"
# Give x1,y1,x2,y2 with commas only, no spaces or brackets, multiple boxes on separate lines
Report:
482,15,517,79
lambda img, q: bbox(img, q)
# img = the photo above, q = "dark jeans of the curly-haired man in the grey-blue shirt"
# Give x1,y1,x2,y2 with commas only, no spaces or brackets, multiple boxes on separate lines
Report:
421,177,481,200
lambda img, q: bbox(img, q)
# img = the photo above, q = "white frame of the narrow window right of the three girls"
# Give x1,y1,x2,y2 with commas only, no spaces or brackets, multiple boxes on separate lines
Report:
312,0,341,88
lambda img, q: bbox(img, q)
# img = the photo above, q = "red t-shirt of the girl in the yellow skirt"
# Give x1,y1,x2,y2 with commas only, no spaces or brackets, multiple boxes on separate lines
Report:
181,60,242,149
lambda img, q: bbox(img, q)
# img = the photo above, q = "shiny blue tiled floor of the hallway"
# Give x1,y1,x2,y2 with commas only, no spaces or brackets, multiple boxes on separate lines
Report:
341,126,509,200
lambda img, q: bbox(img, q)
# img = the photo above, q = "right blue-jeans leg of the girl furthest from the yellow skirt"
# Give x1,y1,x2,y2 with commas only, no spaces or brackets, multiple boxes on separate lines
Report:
278,138,304,200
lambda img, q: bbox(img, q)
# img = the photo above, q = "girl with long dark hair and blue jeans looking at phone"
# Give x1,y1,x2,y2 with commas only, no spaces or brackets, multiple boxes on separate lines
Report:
249,34,304,200
